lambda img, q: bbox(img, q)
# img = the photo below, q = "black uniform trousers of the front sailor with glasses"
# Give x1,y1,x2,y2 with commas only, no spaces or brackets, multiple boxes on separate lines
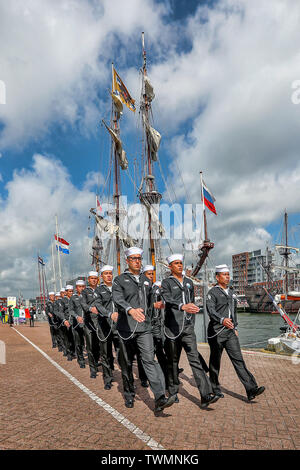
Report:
118,332,165,400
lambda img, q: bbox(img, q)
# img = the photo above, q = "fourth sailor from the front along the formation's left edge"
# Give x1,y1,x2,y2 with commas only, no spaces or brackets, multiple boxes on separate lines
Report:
69,279,86,369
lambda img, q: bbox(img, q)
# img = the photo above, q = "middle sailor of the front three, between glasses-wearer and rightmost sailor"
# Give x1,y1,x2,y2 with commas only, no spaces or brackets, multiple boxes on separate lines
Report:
161,254,218,408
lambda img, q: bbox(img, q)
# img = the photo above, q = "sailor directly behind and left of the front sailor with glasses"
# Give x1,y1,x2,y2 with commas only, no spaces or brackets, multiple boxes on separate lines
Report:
90,265,118,390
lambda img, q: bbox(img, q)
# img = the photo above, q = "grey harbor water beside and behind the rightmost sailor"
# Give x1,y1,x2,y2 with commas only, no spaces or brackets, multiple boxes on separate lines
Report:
195,312,296,349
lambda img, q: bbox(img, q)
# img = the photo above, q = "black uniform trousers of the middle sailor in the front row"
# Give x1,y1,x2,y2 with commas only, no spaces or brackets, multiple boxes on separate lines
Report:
165,325,212,397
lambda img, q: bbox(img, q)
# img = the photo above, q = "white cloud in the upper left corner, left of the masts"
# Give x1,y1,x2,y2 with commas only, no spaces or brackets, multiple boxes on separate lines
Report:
0,0,166,148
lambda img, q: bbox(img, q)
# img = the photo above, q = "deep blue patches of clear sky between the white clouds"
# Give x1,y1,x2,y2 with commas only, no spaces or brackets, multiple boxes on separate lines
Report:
0,0,204,196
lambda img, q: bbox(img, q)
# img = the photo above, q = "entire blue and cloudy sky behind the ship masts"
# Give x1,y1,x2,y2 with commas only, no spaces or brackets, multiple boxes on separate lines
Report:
0,0,300,297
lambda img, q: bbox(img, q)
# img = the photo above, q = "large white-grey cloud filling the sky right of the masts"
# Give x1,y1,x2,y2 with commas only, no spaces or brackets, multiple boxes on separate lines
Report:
139,0,300,262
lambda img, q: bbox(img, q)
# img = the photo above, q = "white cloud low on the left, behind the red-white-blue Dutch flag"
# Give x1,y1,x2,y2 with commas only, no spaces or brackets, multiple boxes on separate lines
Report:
0,155,95,297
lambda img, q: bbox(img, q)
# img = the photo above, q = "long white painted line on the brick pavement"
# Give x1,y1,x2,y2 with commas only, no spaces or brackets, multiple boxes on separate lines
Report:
13,328,165,450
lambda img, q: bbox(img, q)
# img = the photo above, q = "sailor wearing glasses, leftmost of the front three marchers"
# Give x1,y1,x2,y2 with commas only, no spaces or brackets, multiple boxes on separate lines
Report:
113,247,175,411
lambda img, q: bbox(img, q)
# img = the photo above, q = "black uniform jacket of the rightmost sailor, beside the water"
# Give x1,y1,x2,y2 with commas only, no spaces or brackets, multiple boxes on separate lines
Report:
206,286,238,332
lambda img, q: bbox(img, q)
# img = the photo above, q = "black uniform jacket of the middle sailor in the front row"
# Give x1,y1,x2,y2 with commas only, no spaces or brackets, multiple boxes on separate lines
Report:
160,276,195,336
